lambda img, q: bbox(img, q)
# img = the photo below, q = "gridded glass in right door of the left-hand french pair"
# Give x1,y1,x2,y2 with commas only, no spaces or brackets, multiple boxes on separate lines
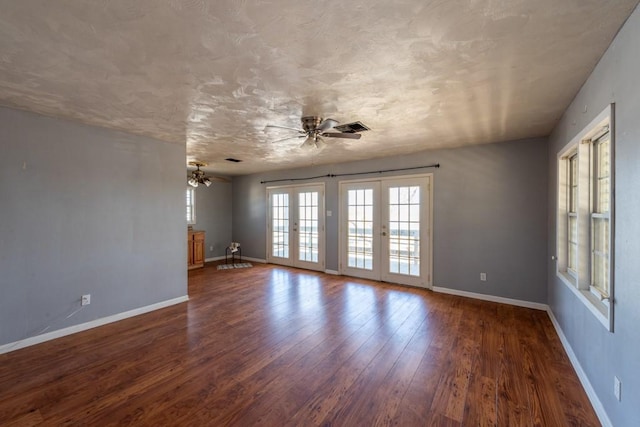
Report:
298,191,319,262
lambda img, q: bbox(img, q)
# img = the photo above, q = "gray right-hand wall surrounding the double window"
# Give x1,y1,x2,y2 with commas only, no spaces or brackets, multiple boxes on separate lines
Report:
548,4,640,426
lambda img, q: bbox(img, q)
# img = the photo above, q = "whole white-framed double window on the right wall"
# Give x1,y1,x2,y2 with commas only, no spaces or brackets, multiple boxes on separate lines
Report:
557,105,614,330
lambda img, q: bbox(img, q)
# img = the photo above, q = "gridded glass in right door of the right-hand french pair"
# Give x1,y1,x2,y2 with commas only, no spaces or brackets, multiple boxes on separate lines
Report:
389,186,420,276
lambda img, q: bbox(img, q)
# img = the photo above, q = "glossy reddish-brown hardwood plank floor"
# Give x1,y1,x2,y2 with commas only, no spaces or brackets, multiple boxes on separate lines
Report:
0,264,599,427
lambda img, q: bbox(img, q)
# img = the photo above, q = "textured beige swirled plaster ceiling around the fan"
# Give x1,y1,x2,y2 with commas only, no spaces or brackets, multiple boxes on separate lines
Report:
0,0,638,175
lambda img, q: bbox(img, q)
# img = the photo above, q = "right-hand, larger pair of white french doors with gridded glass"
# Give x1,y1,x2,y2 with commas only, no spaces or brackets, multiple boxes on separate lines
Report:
340,175,432,287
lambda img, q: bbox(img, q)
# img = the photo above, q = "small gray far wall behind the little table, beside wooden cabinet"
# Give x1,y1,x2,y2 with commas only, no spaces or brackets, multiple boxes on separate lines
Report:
193,182,233,258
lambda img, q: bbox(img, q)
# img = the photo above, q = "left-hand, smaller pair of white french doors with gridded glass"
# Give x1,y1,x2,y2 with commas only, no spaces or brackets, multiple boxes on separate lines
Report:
267,184,325,271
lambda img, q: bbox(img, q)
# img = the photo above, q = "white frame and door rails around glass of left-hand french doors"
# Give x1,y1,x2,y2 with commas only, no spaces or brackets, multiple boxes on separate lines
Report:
266,182,326,271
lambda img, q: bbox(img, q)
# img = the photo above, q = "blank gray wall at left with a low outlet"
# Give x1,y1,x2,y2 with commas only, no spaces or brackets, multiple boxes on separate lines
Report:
0,108,187,345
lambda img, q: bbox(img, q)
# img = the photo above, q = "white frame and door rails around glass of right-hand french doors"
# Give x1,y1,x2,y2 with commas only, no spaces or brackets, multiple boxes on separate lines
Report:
338,173,433,289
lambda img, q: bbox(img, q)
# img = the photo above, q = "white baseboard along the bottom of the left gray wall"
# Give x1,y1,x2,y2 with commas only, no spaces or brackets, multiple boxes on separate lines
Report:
0,295,189,354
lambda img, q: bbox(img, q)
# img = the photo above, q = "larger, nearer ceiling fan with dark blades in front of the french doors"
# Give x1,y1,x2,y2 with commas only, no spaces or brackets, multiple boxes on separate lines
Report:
265,116,369,148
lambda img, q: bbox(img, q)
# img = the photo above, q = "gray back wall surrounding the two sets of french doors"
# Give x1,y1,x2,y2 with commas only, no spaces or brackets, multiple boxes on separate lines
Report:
233,139,547,303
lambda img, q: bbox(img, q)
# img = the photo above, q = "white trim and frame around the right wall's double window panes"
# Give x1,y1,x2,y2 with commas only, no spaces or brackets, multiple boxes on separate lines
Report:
556,104,615,332
